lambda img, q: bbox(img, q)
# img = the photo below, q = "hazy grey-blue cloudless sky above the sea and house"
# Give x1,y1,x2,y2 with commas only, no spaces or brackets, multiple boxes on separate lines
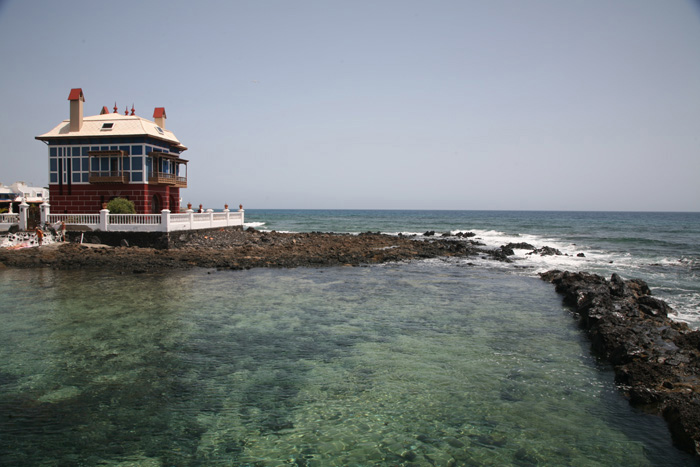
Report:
0,0,700,211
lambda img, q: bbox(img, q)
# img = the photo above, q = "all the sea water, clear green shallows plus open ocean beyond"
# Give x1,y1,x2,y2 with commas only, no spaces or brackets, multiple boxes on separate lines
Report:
0,209,700,467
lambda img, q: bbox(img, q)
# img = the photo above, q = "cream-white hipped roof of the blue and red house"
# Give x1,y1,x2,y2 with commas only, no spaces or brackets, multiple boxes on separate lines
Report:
36,113,187,151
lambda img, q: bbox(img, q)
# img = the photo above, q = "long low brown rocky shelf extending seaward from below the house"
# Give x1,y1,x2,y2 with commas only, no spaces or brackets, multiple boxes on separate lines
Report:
0,229,495,273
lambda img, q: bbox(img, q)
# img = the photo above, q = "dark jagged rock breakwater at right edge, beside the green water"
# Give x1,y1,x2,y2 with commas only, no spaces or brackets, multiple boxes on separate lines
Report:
541,271,700,455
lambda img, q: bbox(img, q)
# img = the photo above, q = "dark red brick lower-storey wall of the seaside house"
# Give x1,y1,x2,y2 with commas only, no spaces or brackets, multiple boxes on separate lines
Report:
49,183,180,214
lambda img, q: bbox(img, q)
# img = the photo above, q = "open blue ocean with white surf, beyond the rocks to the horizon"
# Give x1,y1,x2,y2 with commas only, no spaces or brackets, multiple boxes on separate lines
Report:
246,210,700,328
